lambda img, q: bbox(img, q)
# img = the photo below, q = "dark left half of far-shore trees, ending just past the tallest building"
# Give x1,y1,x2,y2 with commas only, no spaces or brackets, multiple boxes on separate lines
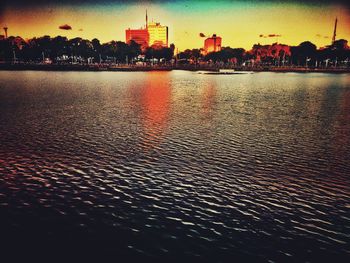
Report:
0,36,175,63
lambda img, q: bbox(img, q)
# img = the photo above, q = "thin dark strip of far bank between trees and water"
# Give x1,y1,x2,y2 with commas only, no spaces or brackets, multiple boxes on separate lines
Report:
0,63,350,73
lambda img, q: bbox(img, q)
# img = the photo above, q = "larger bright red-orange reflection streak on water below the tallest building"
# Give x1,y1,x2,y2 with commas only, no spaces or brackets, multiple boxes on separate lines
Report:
141,71,171,149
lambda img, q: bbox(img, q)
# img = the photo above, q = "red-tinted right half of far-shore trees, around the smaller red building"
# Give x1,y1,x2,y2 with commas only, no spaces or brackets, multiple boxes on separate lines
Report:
178,39,350,67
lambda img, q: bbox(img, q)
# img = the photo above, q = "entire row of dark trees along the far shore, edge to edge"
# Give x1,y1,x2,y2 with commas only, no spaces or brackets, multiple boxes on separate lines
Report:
0,36,350,67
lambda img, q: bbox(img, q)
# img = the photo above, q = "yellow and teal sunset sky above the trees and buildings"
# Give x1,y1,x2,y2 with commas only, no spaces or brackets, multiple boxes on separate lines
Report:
0,0,350,51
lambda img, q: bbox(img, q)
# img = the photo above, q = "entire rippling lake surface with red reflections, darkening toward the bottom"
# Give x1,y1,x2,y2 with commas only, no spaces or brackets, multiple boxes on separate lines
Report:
0,71,350,262
